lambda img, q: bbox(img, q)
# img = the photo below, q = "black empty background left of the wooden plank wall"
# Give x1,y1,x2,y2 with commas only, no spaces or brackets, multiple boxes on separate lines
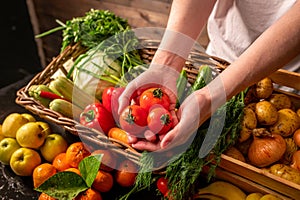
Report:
0,0,42,87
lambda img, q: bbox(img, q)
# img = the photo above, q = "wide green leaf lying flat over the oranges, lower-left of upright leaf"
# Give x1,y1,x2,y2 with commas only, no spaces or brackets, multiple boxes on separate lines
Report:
35,171,89,200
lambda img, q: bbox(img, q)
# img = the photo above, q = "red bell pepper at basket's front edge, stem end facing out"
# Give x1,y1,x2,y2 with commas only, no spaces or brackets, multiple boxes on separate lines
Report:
80,103,115,135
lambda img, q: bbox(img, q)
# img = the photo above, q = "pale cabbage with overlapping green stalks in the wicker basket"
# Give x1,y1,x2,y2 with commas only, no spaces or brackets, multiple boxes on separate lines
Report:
68,30,144,86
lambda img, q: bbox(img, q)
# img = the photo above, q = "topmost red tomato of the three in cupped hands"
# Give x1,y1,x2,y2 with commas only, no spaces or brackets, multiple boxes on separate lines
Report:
139,88,170,111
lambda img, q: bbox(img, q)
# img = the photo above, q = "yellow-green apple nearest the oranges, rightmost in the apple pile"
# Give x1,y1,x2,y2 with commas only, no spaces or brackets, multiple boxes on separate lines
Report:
40,133,68,162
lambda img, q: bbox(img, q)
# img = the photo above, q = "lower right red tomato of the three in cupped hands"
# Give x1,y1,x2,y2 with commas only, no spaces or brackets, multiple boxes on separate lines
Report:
147,106,173,134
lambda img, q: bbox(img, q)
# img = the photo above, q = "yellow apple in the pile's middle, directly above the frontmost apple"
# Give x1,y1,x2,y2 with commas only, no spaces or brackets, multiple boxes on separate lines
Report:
16,122,47,149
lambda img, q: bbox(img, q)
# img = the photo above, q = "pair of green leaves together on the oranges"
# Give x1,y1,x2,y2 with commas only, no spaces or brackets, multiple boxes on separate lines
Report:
35,154,103,200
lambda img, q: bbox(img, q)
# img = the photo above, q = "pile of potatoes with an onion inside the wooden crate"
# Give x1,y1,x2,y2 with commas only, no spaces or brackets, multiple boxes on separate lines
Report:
225,77,300,184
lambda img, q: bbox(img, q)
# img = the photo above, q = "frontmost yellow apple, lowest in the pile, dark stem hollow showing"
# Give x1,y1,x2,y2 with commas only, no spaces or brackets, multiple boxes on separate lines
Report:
9,147,42,176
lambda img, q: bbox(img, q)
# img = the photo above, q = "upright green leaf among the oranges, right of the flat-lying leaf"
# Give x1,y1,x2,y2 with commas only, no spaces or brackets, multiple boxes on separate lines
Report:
78,154,103,187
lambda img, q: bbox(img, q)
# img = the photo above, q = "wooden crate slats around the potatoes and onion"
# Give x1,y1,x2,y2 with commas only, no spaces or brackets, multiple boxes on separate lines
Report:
219,69,300,199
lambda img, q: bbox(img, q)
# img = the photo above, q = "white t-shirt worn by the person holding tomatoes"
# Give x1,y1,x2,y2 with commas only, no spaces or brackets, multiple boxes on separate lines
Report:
207,0,300,72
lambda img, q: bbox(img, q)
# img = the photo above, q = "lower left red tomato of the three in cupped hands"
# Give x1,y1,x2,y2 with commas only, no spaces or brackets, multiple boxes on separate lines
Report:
119,105,147,135
